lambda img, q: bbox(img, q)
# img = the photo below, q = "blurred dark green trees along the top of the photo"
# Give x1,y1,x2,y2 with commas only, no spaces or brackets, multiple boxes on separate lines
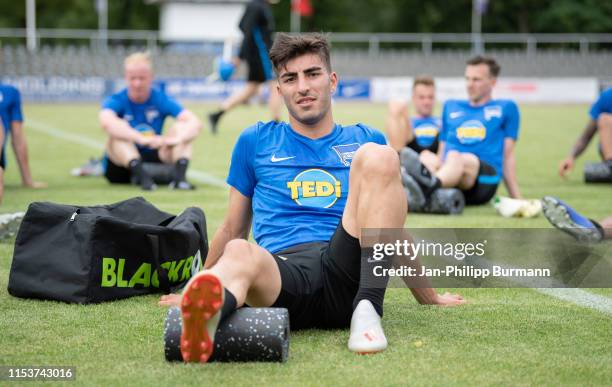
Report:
0,0,612,33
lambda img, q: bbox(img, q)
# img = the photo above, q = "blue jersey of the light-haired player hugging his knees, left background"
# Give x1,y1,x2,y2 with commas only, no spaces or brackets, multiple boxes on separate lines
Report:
102,89,183,153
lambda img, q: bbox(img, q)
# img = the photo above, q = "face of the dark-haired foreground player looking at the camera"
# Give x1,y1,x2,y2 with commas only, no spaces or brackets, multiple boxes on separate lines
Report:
278,54,338,126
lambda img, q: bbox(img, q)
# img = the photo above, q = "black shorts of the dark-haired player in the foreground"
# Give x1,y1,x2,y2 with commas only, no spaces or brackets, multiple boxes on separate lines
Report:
272,221,361,329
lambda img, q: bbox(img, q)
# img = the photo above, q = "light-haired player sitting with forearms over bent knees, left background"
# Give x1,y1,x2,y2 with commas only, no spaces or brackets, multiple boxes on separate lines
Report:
100,53,202,190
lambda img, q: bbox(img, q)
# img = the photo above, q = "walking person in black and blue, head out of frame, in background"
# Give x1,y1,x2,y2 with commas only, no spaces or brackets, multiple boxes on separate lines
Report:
208,0,281,133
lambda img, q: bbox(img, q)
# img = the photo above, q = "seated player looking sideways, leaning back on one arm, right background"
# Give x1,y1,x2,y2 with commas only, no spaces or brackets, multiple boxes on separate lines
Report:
406,56,521,204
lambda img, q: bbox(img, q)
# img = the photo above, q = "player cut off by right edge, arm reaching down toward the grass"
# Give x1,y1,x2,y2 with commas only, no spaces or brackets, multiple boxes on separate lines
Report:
559,88,612,181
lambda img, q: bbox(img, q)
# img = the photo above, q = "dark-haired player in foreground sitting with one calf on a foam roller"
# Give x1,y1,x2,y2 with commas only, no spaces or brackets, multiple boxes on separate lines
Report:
160,34,464,362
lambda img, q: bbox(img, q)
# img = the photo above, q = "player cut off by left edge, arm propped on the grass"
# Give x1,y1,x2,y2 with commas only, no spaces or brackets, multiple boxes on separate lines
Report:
0,84,47,203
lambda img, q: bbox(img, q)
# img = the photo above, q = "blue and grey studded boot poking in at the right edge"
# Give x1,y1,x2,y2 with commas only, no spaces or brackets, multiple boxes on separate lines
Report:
542,196,612,242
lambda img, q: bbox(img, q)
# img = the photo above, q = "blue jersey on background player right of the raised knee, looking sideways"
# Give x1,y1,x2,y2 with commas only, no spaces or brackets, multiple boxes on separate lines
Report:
440,99,520,184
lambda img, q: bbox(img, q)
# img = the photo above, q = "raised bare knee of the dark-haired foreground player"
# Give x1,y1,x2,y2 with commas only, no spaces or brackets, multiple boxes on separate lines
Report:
355,143,400,179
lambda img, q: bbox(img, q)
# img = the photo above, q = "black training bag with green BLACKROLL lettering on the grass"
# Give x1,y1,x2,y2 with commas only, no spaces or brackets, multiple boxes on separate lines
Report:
8,197,208,304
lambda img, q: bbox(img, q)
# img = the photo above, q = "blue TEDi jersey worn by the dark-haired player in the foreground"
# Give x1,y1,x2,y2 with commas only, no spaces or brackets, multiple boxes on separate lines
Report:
227,121,386,253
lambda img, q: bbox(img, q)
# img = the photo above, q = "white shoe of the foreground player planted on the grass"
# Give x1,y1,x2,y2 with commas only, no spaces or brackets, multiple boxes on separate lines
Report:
348,300,387,355
